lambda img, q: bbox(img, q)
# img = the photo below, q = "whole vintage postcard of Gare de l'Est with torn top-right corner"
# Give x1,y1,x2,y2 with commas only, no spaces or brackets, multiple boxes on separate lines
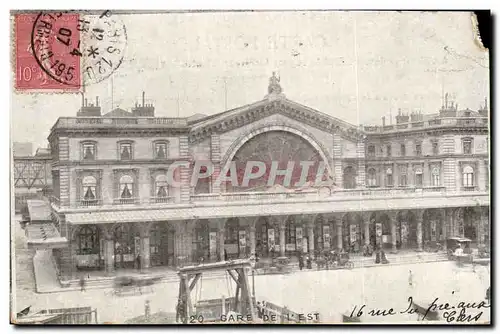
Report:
10,9,492,325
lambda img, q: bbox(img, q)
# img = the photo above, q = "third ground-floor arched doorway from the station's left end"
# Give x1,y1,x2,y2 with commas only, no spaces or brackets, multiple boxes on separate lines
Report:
149,222,175,267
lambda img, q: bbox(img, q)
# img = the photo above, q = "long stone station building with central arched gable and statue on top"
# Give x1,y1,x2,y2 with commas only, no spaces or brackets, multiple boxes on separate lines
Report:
43,76,490,277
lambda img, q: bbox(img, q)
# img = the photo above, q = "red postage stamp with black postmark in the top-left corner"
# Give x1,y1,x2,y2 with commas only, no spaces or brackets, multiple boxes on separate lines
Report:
14,12,82,91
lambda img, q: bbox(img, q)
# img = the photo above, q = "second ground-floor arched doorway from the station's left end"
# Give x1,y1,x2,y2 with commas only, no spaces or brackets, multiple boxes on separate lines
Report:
113,224,139,269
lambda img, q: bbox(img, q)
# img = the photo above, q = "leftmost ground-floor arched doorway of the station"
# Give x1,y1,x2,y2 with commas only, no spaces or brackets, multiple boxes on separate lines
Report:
75,225,104,269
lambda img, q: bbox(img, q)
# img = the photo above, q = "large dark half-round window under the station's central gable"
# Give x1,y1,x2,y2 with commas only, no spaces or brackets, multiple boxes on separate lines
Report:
222,130,329,192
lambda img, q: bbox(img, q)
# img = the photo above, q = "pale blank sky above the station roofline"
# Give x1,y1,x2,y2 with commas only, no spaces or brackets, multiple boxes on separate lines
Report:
11,11,489,148
